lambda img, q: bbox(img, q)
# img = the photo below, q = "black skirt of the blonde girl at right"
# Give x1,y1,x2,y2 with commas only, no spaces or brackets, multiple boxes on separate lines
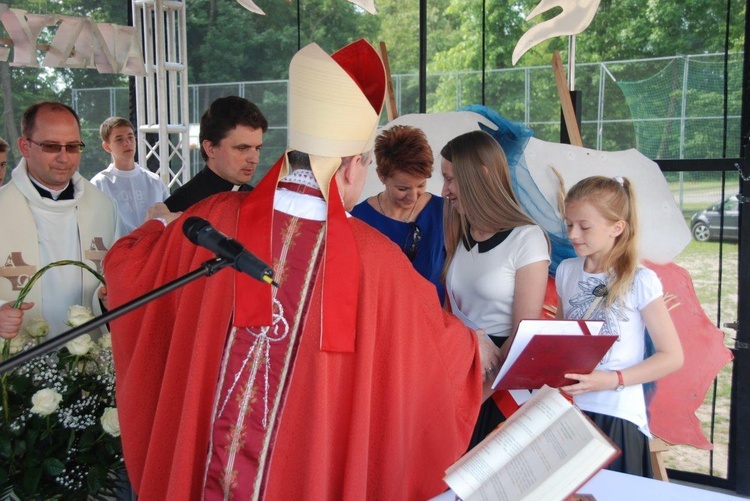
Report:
585,412,654,478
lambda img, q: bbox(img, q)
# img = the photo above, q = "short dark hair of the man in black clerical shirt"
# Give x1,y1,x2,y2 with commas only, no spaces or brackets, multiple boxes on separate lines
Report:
198,96,268,162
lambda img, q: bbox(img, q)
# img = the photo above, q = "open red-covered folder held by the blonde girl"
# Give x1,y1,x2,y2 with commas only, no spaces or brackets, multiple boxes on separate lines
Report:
492,320,617,390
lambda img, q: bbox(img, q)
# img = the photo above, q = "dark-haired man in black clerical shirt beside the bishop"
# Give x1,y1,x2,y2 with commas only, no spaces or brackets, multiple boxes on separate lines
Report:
164,96,268,212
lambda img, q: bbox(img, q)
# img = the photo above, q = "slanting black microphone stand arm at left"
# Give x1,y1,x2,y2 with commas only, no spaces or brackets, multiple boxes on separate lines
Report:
0,257,233,374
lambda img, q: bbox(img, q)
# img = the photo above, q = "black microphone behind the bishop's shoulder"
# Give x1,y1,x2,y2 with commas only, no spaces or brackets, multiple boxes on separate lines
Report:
182,216,279,287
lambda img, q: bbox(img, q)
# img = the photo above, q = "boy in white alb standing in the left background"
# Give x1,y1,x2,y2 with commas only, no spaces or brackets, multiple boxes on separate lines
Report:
91,117,169,233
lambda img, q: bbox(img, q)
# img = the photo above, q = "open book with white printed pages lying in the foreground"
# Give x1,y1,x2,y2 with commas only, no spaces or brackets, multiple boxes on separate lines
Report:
444,386,620,501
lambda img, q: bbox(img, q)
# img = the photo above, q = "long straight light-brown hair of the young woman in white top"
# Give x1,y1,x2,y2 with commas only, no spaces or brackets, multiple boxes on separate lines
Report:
440,131,536,271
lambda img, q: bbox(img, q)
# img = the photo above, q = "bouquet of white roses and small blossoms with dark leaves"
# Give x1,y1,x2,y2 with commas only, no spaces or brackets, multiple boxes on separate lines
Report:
0,262,123,499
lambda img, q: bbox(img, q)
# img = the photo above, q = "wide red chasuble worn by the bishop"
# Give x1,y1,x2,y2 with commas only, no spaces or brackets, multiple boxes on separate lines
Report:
105,189,482,501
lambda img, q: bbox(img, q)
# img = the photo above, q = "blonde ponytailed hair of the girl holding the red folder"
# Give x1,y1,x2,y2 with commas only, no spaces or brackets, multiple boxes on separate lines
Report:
565,176,639,306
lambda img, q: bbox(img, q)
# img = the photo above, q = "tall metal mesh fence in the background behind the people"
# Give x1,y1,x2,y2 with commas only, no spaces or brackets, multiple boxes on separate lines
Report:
72,53,742,183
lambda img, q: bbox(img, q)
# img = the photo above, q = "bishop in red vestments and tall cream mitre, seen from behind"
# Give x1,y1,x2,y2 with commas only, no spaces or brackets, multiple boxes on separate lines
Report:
105,41,494,501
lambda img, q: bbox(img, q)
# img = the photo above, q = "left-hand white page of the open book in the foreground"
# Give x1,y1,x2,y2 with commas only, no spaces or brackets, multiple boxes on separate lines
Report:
444,386,573,500
